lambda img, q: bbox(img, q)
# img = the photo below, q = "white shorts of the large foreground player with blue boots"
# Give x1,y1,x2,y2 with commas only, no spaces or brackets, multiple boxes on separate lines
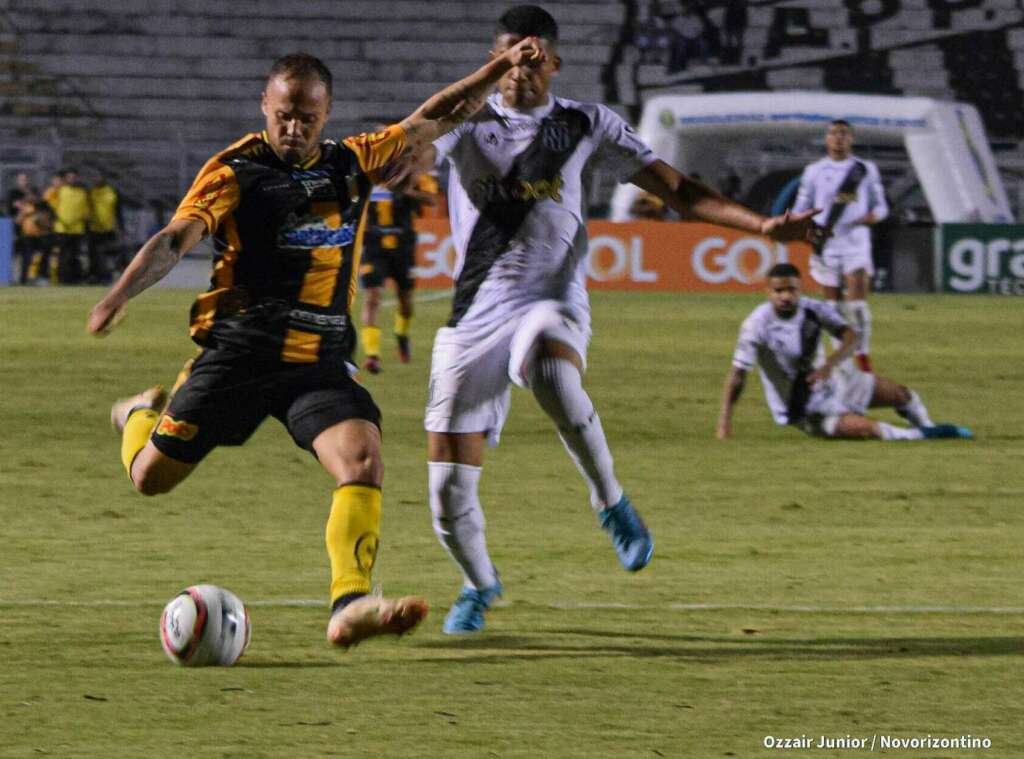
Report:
423,300,590,446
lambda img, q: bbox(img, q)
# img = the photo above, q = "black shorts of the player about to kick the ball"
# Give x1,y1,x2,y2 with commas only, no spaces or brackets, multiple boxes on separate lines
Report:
152,349,381,464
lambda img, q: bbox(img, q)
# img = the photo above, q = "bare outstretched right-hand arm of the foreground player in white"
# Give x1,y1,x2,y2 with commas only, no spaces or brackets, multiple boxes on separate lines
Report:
630,161,819,242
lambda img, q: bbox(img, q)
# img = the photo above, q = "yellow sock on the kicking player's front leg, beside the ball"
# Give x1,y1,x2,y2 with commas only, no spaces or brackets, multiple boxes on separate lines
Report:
327,484,381,603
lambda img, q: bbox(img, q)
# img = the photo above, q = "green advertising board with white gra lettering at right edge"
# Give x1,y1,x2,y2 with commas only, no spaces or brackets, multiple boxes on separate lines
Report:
935,224,1024,295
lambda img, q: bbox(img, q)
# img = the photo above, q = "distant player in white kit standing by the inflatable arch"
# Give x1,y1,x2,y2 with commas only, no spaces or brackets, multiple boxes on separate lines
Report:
793,119,889,372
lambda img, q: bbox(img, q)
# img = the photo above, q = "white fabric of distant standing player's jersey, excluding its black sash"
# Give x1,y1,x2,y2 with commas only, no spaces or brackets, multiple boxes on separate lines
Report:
793,156,889,249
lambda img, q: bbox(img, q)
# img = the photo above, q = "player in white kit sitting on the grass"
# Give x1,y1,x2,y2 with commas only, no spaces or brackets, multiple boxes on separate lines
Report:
718,263,972,440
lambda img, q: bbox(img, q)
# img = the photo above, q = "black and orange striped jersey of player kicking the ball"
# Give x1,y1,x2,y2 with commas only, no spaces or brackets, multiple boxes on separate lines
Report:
174,125,406,364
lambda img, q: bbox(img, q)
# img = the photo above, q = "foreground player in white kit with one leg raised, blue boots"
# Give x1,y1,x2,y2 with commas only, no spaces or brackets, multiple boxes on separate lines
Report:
411,5,813,634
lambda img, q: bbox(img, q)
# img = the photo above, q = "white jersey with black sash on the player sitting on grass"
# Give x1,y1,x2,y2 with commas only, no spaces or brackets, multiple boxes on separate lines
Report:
732,298,849,424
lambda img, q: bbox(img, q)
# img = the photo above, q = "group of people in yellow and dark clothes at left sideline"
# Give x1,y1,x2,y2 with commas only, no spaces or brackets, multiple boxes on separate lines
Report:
3,168,127,286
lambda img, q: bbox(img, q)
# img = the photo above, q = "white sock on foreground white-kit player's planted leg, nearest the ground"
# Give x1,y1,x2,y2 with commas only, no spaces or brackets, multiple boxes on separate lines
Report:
427,461,498,590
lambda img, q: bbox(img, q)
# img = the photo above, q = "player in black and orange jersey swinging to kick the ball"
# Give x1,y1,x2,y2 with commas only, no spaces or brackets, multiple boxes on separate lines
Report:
88,39,544,647
